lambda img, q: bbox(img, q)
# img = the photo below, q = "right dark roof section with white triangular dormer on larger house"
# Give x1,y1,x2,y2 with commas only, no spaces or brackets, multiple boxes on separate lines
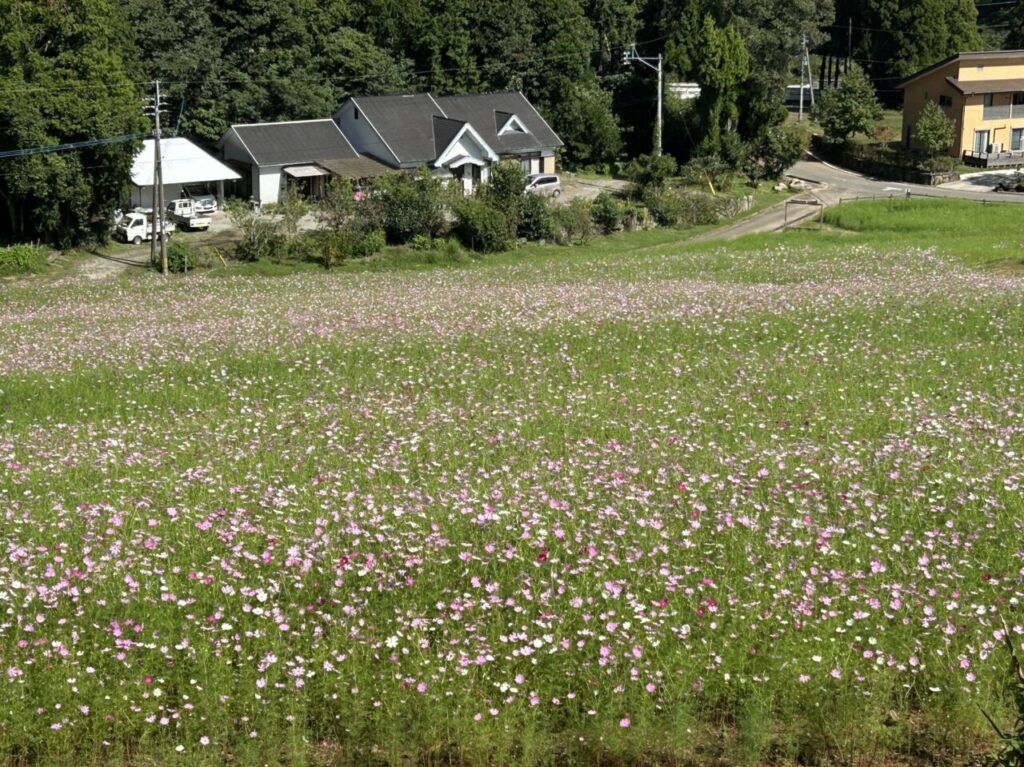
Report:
436,92,563,154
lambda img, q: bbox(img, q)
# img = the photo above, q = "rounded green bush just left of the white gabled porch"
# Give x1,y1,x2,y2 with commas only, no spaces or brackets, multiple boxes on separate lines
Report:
362,170,451,245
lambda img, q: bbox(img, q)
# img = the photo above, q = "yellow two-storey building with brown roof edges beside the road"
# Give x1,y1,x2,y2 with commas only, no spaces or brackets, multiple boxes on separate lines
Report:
900,50,1024,167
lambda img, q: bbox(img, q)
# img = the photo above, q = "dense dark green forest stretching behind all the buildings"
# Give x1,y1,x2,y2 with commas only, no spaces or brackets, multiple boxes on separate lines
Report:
0,0,1007,242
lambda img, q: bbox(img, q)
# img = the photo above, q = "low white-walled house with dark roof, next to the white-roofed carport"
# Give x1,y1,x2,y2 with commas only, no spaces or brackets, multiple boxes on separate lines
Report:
217,119,389,205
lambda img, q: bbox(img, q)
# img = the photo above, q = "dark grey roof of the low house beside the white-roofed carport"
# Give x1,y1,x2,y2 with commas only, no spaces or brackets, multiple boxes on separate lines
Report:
220,120,359,166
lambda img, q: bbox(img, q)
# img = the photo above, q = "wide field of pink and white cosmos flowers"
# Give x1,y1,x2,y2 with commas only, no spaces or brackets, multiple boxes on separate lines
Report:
0,200,1024,766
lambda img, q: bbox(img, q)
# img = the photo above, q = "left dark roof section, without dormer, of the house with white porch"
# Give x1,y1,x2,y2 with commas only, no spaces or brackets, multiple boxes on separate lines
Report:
351,93,446,165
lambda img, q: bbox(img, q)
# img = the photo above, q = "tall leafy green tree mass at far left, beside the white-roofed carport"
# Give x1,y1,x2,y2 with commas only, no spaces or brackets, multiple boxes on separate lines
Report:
0,0,145,246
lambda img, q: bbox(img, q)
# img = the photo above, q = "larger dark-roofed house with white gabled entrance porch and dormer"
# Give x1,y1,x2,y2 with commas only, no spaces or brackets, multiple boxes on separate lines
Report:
334,93,562,194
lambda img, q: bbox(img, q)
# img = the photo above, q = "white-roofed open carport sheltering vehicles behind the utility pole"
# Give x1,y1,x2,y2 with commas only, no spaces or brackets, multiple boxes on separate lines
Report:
131,137,241,208
